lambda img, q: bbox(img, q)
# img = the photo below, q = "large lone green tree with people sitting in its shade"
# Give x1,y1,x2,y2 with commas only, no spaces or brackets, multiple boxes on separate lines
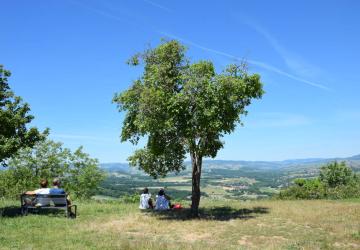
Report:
113,40,263,216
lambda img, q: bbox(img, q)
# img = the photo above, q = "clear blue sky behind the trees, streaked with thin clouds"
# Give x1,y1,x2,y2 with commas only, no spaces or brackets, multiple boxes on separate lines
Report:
0,0,360,162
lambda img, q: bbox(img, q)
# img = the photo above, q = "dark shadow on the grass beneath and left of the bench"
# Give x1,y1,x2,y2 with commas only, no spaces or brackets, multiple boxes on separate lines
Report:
0,206,65,218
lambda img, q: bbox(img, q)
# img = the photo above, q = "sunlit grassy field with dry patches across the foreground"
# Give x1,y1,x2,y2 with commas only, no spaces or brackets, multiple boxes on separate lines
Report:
0,199,360,249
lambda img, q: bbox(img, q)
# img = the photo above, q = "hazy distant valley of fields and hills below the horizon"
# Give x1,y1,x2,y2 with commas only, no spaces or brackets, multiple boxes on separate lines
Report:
98,156,360,200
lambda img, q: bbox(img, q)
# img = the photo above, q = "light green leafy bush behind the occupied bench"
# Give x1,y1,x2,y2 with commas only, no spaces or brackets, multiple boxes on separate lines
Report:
0,140,105,198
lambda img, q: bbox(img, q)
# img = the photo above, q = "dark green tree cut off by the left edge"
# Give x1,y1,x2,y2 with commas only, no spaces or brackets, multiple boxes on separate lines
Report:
0,65,47,165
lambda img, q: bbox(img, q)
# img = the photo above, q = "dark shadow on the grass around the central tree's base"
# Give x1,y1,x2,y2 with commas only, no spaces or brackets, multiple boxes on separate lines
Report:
144,206,269,221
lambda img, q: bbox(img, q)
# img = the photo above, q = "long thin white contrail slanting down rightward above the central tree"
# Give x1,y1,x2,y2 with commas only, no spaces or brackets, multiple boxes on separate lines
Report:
158,31,331,91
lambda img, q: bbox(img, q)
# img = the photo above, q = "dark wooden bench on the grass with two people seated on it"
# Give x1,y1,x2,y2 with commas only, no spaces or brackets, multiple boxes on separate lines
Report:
20,194,77,218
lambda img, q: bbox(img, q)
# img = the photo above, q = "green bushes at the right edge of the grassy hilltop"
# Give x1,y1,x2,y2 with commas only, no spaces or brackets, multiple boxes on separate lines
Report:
278,161,360,199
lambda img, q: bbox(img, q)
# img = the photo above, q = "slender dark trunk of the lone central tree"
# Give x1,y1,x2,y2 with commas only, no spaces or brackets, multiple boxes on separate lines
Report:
190,152,202,217
